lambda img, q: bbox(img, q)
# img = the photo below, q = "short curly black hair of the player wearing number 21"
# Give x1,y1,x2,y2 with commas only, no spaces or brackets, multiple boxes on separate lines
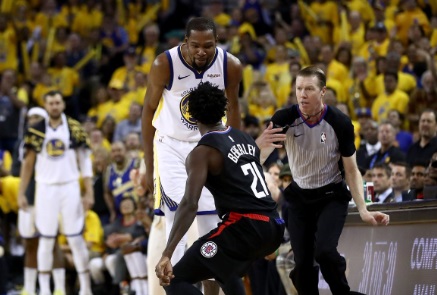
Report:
188,81,228,125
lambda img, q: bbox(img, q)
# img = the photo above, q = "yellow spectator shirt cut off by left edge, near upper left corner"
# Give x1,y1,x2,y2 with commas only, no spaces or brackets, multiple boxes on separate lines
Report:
0,28,18,73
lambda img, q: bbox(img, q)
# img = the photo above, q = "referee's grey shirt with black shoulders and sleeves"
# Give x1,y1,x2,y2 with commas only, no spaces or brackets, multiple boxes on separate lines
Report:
272,105,355,189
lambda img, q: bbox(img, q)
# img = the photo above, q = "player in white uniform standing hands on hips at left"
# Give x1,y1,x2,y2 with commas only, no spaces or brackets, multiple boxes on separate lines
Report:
18,91,94,295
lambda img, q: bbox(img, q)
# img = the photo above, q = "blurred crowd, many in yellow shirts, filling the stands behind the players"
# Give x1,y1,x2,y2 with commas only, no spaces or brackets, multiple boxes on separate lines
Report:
0,0,437,295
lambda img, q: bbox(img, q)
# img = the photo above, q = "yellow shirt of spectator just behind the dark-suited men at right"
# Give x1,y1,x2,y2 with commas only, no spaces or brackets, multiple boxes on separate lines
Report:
372,90,410,122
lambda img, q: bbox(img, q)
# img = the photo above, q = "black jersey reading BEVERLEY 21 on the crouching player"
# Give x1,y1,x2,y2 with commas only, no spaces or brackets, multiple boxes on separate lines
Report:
199,127,276,216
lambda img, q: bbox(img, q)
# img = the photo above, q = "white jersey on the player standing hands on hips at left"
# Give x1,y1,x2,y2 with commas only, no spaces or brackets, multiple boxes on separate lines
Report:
35,114,80,184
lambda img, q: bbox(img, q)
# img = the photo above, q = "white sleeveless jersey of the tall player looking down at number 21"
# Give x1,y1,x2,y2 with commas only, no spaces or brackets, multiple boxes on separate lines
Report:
153,46,227,142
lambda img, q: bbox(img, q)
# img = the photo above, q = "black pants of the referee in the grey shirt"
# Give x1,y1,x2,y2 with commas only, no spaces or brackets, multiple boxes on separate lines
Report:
284,183,350,295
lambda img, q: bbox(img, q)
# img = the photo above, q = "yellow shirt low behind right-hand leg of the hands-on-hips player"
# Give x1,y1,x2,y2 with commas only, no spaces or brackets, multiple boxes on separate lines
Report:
58,210,105,253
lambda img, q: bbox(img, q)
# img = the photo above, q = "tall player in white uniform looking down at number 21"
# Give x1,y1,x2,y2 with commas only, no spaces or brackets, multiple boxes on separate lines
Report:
142,17,242,294
